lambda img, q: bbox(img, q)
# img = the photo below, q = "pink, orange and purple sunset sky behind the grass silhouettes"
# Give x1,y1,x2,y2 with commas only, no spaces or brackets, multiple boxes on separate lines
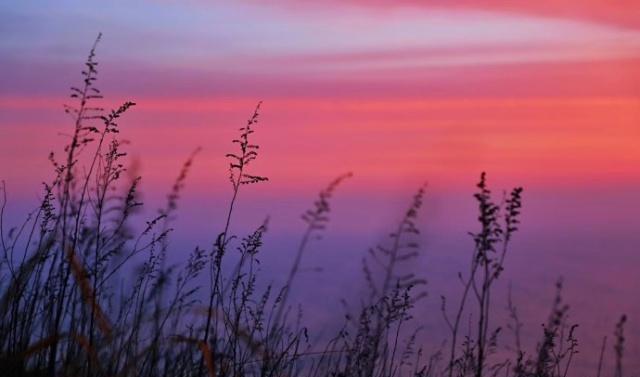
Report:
0,0,640,370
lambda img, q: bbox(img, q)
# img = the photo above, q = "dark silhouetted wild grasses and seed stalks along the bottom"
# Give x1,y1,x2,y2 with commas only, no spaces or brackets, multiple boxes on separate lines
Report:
0,38,626,377
